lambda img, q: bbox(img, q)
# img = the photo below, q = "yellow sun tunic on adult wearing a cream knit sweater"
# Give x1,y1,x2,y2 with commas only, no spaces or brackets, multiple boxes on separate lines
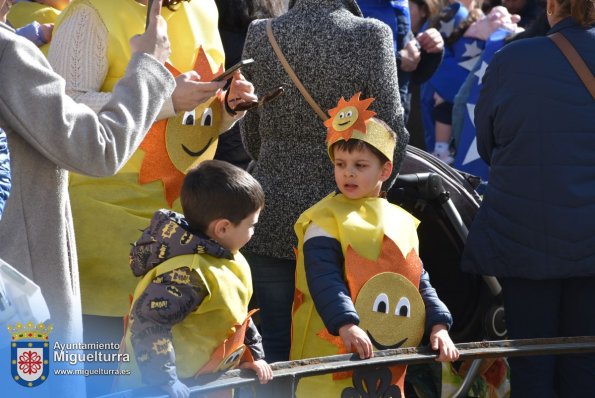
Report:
56,0,233,316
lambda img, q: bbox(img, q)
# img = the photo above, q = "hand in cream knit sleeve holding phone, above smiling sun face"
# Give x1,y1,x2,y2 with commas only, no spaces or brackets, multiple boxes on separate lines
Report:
171,71,225,112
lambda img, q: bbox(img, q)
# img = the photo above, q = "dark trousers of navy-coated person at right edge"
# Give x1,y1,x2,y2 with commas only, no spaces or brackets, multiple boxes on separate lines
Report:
500,277,595,398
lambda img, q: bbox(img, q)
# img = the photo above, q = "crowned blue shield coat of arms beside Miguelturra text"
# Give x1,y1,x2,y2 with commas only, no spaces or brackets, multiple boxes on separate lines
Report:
8,322,53,387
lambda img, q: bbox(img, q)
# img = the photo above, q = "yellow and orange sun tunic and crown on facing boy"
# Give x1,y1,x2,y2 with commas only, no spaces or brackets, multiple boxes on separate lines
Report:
290,93,426,397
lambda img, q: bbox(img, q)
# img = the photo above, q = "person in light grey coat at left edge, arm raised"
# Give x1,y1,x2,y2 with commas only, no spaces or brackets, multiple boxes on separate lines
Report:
0,0,175,397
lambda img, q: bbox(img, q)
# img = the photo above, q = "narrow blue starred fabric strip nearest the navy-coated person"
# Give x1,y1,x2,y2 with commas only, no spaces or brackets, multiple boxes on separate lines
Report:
453,29,510,181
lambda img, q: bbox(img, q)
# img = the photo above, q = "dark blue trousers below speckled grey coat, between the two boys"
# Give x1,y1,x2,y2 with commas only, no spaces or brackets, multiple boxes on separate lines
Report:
243,253,295,363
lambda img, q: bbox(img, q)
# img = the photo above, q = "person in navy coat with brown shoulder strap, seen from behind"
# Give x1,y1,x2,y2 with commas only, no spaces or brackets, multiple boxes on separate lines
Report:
462,0,595,398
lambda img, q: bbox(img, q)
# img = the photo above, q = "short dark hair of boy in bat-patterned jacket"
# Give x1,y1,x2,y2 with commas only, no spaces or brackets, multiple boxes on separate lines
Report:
180,160,264,234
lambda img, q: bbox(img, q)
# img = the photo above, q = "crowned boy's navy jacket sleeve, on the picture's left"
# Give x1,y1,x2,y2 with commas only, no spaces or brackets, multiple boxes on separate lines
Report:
304,237,359,336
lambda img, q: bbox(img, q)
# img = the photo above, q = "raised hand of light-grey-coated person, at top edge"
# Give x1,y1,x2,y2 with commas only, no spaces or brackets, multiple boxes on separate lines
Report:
130,0,171,64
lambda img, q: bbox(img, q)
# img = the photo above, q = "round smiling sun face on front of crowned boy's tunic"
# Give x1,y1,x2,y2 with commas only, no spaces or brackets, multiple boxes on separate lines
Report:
355,272,425,350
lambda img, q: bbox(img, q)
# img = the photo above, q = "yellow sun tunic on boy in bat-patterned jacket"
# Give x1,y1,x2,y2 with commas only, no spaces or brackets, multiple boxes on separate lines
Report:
118,253,252,389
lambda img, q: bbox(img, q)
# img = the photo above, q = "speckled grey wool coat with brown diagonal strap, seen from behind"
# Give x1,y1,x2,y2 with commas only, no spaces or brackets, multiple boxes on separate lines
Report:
240,0,409,258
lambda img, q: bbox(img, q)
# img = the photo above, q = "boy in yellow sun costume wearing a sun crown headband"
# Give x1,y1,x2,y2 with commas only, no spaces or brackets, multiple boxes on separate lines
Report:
291,93,458,397
